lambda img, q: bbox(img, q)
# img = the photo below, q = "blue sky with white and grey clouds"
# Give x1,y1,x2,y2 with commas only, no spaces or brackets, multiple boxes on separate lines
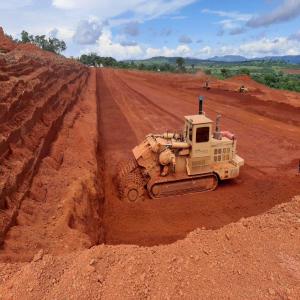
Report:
0,0,300,60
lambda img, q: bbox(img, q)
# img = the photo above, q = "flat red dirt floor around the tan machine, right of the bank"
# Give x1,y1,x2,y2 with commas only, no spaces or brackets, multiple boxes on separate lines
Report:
97,70,300,245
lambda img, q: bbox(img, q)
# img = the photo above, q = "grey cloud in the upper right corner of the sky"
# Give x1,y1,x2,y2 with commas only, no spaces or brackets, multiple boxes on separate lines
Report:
247,0,300,27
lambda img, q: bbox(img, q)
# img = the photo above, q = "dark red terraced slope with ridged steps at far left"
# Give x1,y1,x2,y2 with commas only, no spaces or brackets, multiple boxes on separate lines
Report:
0,47,89,242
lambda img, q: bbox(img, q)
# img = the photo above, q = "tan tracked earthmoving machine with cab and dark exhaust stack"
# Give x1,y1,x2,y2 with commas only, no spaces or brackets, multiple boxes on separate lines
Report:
117,97,244,202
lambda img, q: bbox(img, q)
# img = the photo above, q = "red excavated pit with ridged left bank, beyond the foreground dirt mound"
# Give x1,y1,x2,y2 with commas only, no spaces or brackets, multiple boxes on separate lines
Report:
0,39,300,268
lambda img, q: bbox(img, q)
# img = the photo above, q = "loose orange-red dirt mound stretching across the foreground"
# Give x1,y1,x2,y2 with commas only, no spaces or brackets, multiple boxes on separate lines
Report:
0,198,300,299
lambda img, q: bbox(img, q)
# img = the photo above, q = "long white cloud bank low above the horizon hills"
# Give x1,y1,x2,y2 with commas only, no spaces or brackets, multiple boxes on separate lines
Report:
84,28,300,60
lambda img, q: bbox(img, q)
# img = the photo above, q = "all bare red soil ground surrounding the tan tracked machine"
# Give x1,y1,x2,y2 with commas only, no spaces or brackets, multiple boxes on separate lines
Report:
0,31,300,299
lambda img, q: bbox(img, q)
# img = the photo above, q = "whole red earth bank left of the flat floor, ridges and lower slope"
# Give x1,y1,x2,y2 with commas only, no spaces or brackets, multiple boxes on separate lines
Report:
0,50,103,261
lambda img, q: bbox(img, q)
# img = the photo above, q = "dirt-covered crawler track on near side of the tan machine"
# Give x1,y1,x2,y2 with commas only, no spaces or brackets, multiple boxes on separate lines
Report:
147,173,218,198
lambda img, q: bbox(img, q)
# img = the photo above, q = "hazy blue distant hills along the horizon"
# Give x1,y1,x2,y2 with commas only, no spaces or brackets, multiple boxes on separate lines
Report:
126,55,300,65
